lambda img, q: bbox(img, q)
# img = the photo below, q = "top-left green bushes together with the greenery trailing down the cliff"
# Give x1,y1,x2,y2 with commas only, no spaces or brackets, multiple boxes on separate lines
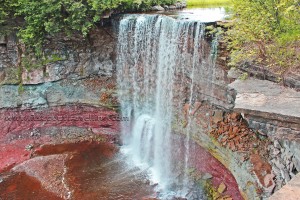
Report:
0,0,176,87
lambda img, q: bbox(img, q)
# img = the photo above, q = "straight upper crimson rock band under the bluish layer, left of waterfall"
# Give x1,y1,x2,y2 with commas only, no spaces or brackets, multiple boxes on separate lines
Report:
0,106,119,136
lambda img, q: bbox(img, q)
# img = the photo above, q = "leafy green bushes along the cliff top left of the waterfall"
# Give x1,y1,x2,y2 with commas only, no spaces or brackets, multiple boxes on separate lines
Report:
0,0,175,54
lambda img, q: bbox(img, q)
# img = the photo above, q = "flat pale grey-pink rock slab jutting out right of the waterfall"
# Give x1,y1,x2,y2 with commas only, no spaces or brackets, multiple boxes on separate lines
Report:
229,79,300,124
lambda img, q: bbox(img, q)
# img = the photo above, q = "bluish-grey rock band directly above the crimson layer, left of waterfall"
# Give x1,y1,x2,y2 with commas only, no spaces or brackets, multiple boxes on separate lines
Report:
0,77,117,109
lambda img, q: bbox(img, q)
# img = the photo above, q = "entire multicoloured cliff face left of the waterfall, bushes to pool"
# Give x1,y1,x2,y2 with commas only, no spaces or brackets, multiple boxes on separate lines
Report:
0,23,120,171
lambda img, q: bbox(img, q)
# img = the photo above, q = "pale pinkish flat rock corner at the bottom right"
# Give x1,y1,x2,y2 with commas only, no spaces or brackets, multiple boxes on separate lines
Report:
269,173,300,200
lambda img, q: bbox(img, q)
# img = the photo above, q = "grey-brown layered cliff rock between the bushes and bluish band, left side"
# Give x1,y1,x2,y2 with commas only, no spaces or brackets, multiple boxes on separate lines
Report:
0,26,116,85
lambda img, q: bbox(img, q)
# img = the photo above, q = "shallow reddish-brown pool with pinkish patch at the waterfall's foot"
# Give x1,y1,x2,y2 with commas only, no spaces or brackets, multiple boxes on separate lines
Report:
0,141,155,200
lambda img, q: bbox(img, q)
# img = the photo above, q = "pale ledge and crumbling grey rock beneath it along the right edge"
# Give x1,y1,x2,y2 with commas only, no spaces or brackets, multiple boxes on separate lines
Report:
230,79,300,197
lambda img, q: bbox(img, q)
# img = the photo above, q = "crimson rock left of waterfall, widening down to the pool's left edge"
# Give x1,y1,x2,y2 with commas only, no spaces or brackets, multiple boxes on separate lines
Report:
0,106,119,172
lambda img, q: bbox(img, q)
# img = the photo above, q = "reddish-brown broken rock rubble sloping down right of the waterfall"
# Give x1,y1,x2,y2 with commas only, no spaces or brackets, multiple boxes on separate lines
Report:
210,111,276,194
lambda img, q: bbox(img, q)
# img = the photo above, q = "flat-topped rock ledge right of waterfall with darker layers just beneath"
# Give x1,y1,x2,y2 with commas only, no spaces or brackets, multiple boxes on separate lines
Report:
229,79,300,139
